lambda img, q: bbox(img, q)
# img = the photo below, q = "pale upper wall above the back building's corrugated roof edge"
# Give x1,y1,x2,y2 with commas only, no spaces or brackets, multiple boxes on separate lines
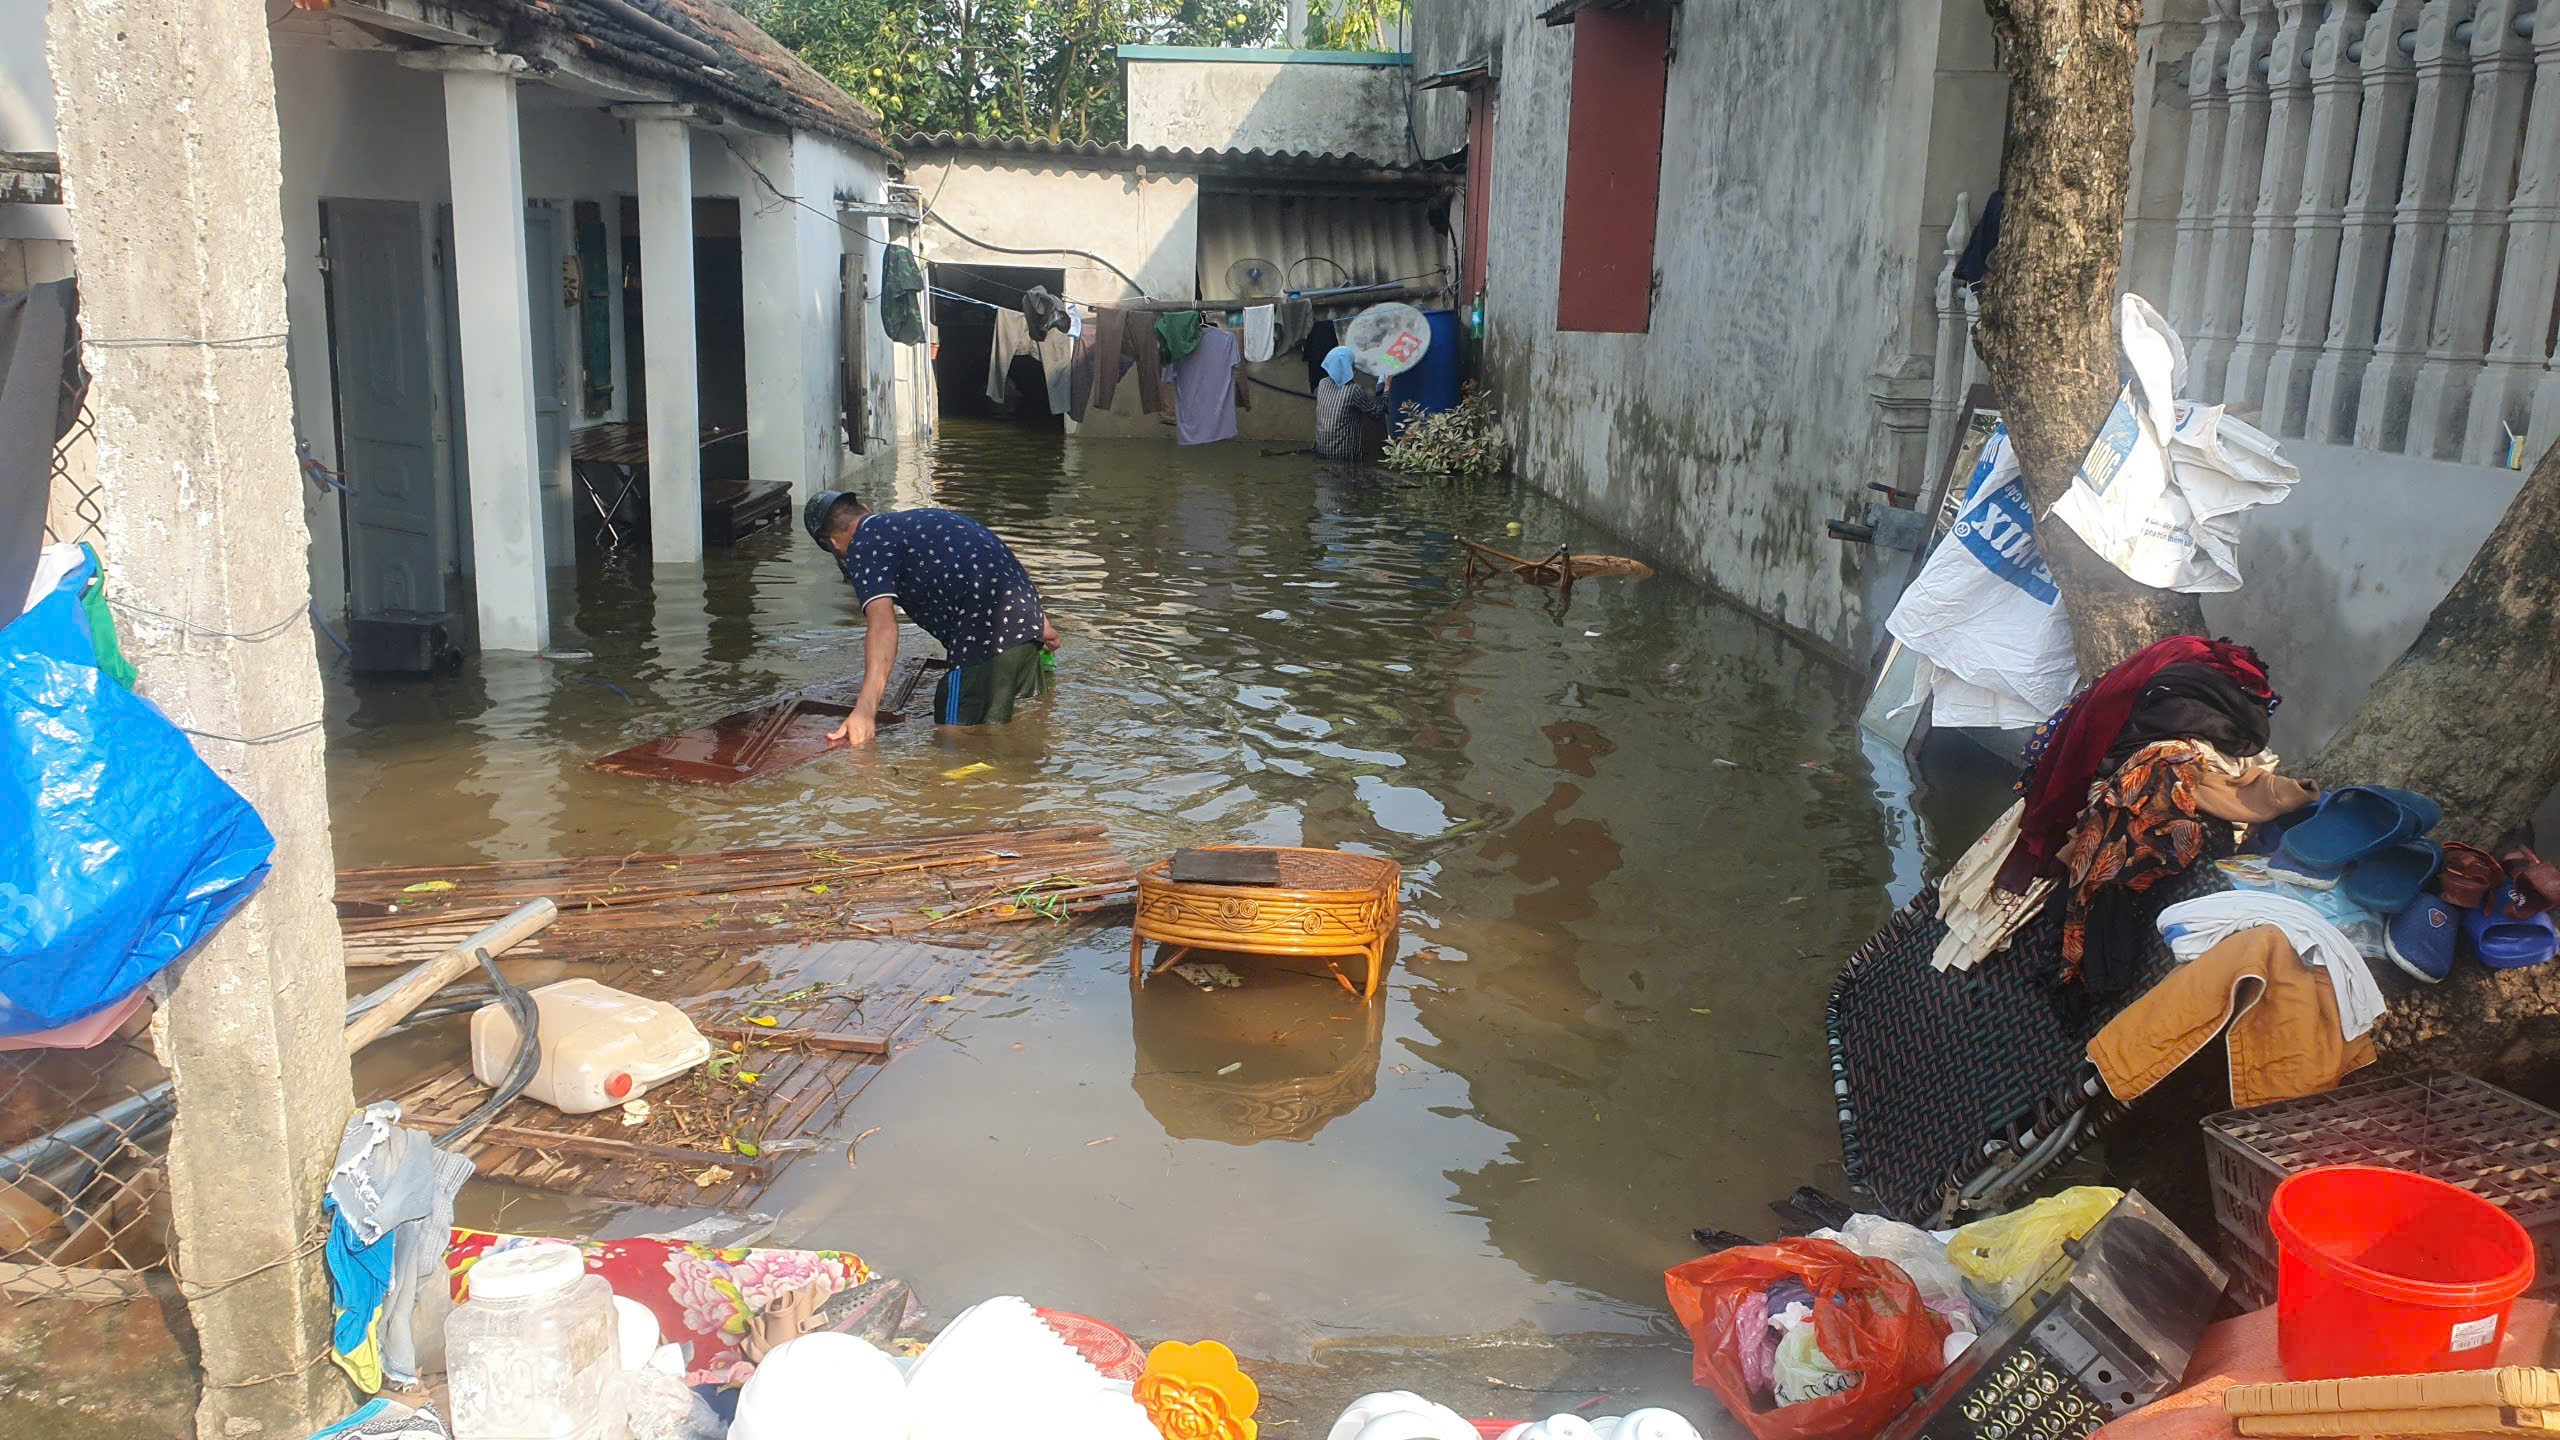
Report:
1121,46,1413,164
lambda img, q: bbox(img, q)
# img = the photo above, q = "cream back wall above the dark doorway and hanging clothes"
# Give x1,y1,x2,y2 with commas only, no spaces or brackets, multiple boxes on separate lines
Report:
909,156,1201,436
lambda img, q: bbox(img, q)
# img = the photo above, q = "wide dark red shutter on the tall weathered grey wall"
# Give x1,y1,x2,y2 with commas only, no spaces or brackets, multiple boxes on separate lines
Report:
1556,8,1672,333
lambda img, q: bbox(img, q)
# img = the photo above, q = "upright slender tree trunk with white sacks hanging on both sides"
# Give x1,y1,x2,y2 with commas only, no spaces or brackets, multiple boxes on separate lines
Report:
1976,0,2204,679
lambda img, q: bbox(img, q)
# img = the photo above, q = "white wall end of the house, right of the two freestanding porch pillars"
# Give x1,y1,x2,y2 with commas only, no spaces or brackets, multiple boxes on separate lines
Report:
732,136,824,500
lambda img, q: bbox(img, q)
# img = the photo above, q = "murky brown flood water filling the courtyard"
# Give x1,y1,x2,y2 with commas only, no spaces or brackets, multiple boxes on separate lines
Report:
330,428,1920,1393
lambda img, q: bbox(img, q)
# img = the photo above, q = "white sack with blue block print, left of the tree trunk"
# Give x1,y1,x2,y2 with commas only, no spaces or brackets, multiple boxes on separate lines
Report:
1884,417,2079,730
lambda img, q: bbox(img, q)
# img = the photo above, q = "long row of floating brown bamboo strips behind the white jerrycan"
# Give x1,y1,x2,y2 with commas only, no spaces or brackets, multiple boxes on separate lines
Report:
338,825,1137,966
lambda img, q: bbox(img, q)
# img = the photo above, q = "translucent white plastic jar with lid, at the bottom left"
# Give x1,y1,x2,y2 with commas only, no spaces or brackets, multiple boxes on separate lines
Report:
445,1243,625,1440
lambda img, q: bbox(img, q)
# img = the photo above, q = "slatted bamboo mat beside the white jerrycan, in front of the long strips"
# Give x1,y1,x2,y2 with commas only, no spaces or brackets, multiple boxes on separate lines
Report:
371,940,1011,1209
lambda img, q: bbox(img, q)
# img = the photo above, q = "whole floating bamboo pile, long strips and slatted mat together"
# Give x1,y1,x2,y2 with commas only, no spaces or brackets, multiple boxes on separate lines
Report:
338,825,1137,1207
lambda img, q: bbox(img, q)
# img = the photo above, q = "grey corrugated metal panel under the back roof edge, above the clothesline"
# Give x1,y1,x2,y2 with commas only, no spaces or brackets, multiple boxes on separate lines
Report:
1201,192,1449,295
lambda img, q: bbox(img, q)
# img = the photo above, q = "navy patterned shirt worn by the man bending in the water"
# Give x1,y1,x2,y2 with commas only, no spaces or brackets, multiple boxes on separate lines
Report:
845,510,1042,666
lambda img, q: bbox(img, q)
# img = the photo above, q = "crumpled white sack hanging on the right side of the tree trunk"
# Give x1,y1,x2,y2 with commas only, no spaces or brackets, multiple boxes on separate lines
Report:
2053,295,2301,594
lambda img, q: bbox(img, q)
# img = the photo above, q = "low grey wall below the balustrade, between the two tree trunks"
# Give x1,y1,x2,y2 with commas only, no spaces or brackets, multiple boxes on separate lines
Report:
2204,441,2524,758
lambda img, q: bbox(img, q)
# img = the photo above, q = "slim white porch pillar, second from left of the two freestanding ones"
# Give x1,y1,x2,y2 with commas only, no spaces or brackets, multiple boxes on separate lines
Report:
627,105,701,564
